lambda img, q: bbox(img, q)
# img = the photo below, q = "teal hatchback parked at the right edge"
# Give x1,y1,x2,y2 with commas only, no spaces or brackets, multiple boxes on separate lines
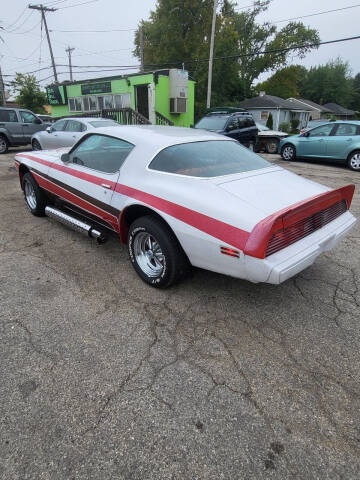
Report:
279,120,360,171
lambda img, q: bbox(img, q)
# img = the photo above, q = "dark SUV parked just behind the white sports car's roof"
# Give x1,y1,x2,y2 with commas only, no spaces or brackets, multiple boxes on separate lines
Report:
195,109,258,150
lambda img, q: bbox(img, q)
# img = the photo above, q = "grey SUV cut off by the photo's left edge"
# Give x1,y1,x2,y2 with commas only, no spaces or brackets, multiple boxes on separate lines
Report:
0,107,49,153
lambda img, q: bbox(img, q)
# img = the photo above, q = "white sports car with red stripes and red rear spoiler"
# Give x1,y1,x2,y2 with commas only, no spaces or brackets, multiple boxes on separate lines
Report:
15,126,356,287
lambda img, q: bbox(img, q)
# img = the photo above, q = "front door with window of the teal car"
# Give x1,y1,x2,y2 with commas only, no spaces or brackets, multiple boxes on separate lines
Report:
297,123,335,157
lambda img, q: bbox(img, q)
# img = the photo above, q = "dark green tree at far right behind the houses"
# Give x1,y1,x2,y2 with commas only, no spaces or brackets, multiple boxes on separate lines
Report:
300,58,352,106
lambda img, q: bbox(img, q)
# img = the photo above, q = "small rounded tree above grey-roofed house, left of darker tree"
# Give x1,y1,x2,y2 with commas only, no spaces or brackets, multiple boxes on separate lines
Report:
256,65,307,98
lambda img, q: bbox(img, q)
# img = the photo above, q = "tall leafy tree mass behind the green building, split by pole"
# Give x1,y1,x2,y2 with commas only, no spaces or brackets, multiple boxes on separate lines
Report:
134,0,319,114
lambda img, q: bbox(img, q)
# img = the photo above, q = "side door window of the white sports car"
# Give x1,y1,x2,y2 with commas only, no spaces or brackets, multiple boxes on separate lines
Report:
70,134,134,173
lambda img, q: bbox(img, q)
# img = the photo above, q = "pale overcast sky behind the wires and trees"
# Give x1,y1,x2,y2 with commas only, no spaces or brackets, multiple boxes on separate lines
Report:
0,0,360,92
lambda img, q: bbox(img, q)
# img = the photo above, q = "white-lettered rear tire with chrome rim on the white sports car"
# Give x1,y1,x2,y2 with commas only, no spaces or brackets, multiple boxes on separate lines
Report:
128,215,189,288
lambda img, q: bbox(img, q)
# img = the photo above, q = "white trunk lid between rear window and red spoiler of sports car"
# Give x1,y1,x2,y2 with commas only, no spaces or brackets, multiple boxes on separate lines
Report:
214,167,330,215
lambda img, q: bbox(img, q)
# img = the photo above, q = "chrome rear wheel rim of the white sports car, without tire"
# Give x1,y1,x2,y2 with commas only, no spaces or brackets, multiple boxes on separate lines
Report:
134,232,165,278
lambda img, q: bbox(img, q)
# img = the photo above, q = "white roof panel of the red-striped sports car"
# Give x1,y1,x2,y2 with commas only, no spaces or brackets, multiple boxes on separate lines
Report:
90,125,233,150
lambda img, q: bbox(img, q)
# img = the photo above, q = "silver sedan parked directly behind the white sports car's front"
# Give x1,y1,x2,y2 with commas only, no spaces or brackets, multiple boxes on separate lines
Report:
31,117,118,150
